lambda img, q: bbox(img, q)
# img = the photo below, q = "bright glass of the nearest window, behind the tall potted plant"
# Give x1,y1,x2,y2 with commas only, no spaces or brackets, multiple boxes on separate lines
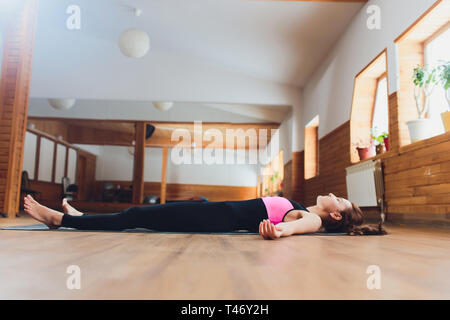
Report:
425,26,450,135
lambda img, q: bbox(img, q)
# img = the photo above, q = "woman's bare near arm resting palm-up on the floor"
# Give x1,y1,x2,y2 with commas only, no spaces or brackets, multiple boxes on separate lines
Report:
259,213,322,240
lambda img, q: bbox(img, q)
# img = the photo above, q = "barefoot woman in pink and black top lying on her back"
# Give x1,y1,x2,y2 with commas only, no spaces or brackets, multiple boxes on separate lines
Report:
24,193,386,240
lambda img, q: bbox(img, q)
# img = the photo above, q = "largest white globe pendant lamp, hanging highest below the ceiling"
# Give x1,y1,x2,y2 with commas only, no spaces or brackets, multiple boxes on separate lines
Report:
119,29,150,59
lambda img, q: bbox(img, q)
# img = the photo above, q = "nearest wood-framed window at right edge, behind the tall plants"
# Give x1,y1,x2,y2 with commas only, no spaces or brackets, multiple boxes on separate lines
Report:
393,0,450,148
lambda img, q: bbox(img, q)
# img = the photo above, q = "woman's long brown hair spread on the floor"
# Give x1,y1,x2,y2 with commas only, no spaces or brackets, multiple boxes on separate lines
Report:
322,202,387,236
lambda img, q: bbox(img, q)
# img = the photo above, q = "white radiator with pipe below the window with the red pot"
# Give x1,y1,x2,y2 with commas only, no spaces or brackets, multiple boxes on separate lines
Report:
345,159,385,221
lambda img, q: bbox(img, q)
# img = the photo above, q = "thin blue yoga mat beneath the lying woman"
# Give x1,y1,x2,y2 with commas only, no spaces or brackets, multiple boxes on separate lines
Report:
0,224,347,236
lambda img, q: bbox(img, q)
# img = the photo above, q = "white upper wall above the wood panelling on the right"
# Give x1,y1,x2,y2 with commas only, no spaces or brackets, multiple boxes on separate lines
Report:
300,0,435,151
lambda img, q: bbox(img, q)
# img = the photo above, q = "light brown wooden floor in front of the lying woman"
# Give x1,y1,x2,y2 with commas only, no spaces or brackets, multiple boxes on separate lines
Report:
0,212,450,300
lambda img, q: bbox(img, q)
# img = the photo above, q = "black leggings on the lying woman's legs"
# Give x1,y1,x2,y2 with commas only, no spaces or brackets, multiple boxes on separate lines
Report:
61,198,267,232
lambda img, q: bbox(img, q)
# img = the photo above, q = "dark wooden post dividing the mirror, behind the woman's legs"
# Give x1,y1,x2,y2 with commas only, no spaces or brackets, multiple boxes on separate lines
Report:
133,122,145,204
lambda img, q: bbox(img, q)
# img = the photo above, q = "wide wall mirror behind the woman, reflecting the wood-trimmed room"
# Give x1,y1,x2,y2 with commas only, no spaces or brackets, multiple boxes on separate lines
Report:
24,97,290,212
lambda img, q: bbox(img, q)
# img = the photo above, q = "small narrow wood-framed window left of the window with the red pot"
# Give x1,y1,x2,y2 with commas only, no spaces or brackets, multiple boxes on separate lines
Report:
305,116,319,180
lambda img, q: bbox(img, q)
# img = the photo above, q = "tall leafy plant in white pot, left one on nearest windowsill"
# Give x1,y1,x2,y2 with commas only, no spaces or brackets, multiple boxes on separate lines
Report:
407,65,438,142
